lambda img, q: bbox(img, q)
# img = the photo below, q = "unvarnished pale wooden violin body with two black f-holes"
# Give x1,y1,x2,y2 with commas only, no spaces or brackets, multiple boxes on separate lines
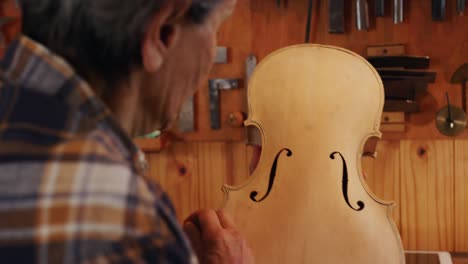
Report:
223,45,404,264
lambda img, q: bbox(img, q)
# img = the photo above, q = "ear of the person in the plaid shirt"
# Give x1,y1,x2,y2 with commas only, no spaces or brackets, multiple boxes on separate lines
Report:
141,3,185,73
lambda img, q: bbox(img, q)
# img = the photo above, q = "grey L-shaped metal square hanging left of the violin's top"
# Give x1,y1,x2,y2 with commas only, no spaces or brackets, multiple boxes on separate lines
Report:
208,79,239,130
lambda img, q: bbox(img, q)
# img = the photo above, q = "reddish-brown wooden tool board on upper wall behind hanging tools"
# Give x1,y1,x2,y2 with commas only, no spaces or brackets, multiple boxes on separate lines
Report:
192,0,468,140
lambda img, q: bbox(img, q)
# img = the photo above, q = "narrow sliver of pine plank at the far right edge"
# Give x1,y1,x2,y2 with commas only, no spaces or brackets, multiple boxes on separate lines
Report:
455,140,468,252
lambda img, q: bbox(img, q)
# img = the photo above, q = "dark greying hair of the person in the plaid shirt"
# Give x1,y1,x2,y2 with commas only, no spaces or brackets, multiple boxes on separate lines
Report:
19,0,221,83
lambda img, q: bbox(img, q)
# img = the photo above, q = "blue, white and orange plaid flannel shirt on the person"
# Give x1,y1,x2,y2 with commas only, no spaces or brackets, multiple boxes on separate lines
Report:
0,36,196,263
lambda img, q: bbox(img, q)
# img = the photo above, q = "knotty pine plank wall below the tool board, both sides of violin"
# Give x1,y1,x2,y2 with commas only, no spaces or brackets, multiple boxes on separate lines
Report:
148,140,468,251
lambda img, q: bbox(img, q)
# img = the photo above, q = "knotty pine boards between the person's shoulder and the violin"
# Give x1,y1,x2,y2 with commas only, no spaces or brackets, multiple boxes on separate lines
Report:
147,142,249,221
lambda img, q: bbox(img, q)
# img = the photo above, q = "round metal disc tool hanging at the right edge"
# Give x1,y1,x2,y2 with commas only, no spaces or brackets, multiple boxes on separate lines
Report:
436,93,466,137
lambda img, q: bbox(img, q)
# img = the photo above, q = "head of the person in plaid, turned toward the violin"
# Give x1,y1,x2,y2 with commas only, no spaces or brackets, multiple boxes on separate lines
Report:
19,0,235,133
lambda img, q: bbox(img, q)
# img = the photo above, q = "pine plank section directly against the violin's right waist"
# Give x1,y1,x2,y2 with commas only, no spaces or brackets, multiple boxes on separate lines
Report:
362,141,401,230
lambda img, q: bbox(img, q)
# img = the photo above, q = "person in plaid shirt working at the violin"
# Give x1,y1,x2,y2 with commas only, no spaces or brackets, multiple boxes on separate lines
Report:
0,0,253,263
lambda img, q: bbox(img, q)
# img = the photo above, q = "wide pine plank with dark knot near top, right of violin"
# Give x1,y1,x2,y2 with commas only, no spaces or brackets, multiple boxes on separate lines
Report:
400,140,455,250
